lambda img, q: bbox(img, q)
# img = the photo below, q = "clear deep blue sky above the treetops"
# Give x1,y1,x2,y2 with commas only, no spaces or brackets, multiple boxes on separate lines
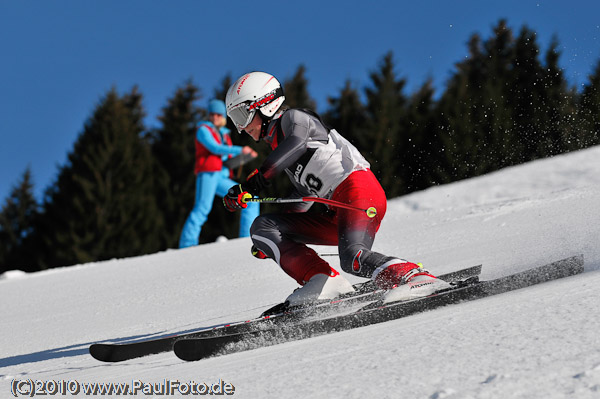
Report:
0,0,600,205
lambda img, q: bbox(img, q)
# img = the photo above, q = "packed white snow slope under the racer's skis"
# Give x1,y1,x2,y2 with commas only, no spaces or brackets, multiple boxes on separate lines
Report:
0,147,600,399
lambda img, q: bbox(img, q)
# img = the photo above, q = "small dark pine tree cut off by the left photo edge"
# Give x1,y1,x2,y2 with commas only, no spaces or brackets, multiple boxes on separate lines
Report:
0,168,39,274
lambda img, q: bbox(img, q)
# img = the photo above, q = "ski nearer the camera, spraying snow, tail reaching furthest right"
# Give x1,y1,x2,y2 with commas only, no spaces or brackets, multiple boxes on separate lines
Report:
173,255,583,361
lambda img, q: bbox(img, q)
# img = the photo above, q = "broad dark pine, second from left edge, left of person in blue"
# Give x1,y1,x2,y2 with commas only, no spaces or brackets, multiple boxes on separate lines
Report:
36,88,164,267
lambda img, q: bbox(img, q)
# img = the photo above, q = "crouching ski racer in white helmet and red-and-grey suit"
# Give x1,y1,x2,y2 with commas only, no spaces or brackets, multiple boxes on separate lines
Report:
223,72,449,306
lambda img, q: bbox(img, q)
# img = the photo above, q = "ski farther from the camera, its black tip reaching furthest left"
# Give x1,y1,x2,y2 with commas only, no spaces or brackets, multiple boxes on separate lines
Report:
89,265,481,362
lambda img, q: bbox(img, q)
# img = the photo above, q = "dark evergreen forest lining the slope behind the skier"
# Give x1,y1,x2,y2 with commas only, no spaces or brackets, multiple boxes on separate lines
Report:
0,20,600,273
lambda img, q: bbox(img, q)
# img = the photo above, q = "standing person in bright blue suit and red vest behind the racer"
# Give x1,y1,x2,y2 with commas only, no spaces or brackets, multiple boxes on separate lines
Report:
179,99,259,248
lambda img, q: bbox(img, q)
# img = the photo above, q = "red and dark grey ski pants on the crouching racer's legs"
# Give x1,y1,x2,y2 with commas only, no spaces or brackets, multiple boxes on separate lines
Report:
250,170,391,285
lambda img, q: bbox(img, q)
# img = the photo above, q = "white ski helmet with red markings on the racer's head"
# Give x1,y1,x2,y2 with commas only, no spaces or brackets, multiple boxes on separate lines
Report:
225,72,285,132
